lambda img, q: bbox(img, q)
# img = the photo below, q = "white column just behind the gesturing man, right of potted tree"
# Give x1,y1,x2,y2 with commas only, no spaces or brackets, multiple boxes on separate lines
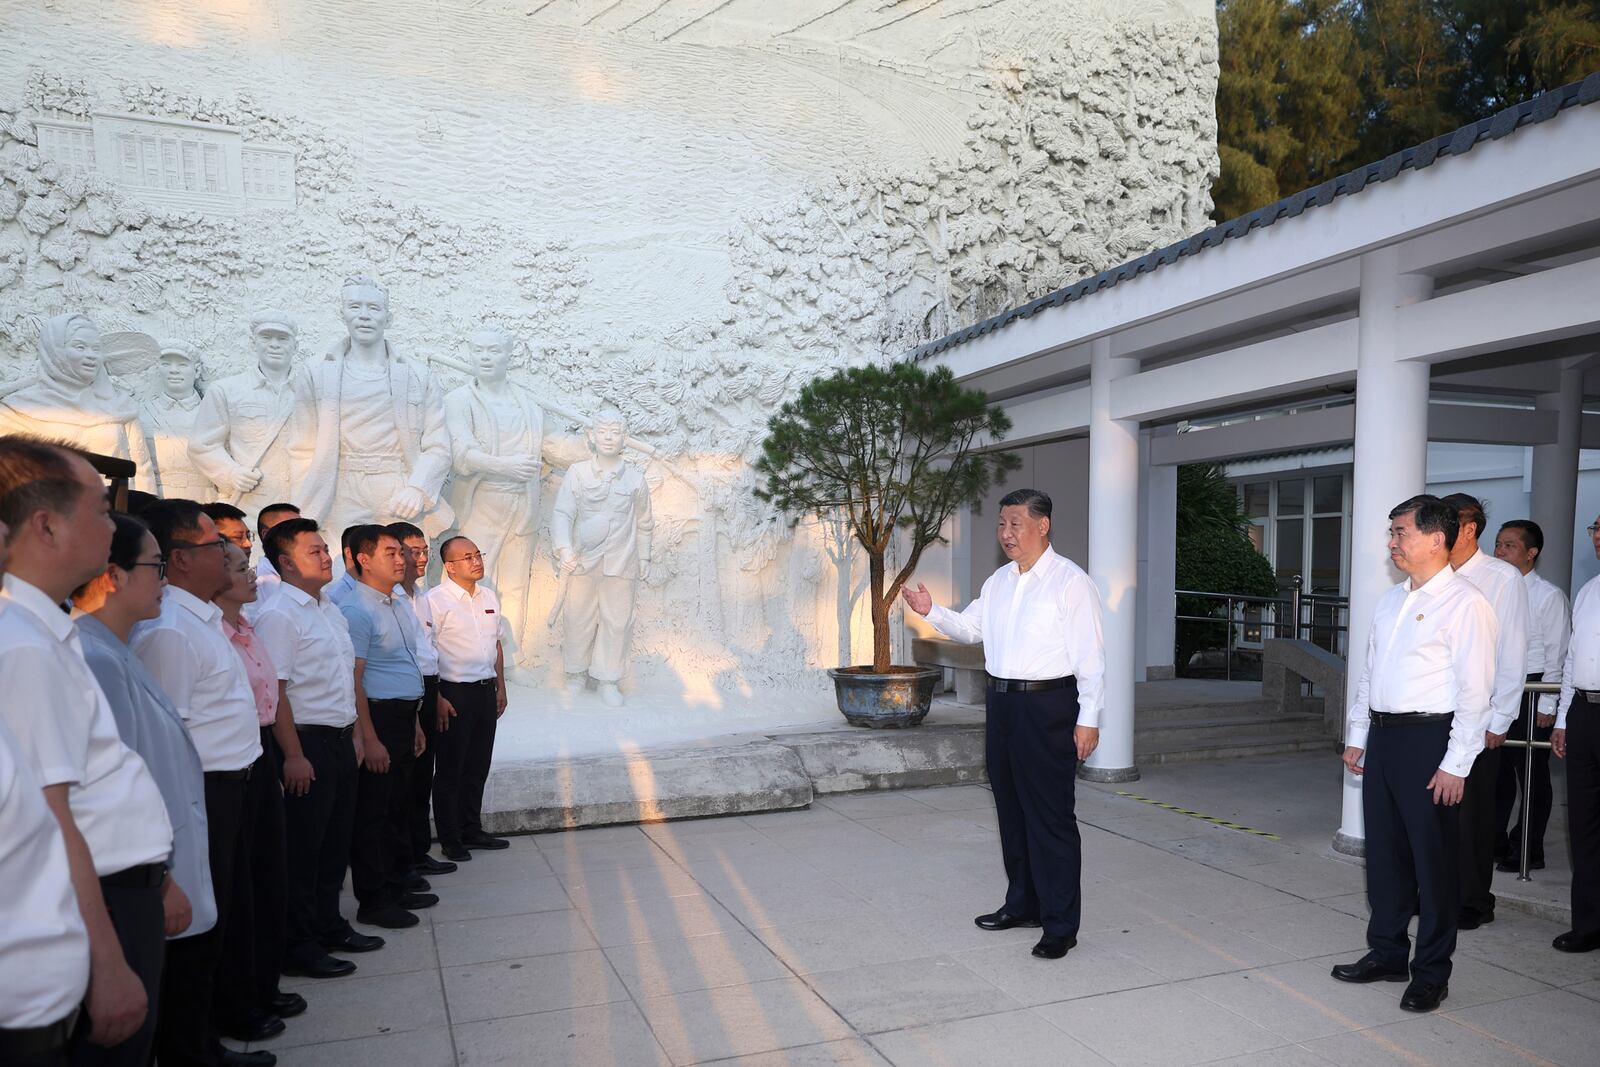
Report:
1078,338,1139,782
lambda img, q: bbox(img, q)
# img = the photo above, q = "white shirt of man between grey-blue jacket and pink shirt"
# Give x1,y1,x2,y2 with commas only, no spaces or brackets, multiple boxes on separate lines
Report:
128,585,261,771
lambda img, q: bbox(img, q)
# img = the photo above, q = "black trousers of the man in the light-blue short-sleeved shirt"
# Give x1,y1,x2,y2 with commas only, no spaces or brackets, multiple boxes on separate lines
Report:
350,697,419,909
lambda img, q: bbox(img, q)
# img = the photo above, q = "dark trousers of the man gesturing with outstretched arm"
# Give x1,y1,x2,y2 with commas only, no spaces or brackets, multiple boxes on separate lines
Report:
984,680,1083,937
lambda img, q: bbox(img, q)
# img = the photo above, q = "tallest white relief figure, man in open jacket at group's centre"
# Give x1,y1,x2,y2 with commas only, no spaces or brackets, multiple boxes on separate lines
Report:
290,275,454,537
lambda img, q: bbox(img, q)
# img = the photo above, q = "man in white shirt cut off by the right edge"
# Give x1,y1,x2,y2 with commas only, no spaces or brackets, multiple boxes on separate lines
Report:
1550,518,1600,952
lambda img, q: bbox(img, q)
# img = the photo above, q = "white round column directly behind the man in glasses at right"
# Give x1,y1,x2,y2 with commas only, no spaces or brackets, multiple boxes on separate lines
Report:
1333,248,1434,856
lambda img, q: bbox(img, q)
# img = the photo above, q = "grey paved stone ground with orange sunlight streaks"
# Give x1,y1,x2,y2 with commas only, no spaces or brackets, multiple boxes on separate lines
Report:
262,755,1600,1067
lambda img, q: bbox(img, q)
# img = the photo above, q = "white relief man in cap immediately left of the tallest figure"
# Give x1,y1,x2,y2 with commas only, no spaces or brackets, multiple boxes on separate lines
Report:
189,309,299,517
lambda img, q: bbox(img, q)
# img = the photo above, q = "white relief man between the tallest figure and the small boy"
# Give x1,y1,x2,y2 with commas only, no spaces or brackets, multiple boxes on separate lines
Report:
445,328,587,662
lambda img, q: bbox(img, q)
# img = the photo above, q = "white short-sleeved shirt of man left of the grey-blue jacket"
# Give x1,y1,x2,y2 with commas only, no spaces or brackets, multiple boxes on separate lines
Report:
0,574,173,877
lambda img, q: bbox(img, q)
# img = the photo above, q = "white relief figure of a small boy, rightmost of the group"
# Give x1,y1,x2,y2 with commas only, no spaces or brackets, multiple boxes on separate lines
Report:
550,408,656,707
